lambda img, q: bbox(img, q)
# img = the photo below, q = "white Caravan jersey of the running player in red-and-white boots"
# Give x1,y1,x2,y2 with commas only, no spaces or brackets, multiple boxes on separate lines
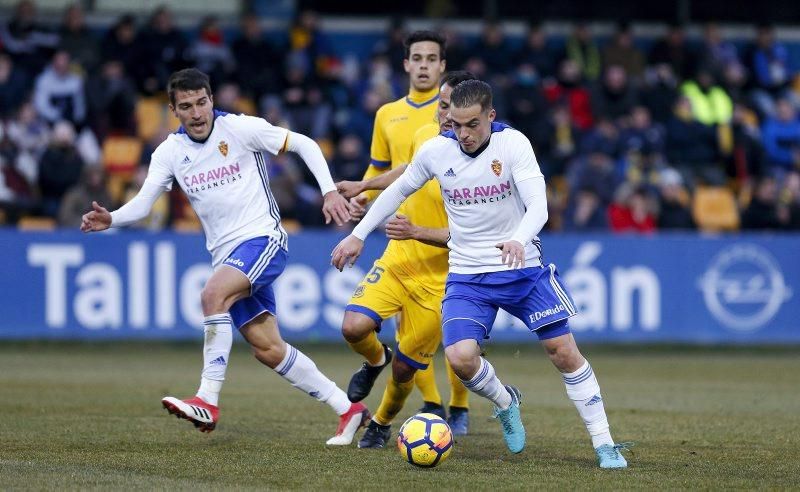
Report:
147,110,289,267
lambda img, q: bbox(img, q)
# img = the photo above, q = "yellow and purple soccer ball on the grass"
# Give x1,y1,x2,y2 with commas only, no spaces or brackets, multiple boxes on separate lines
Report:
397,413,453,468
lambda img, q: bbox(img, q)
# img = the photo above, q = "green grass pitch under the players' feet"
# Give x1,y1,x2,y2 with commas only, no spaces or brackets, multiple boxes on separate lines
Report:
0,340,800,491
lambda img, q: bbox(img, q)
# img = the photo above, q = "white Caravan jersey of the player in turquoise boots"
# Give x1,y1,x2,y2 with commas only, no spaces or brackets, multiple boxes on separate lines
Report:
405,123,542,273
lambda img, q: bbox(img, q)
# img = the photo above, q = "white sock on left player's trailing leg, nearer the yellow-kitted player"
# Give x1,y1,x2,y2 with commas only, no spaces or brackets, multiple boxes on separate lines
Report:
275,343,350,415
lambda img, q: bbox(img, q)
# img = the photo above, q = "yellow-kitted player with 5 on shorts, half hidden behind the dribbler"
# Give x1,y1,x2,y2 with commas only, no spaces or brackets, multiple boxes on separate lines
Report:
339,65,474,448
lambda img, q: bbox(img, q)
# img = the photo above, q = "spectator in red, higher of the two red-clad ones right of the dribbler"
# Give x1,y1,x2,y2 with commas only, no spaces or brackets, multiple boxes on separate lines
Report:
544,60,594,130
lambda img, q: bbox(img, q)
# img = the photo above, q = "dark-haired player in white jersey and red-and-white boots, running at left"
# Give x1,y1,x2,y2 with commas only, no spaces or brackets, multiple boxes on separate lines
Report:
81,69,370,445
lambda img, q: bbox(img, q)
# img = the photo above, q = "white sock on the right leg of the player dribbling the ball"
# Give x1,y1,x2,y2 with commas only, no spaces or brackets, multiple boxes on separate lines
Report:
563,361,614,448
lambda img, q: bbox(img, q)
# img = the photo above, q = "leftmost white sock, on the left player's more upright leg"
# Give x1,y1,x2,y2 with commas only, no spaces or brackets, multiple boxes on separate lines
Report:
197,313,233,406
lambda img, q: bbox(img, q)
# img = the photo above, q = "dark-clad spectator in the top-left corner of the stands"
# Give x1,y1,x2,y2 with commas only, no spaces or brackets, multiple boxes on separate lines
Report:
0,0,58,77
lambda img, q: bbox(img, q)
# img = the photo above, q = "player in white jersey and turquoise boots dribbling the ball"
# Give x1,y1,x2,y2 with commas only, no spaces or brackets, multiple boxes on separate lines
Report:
331,80,627,468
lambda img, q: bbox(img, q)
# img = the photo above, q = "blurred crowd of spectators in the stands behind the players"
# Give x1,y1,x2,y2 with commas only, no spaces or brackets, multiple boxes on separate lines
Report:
0,0,800,233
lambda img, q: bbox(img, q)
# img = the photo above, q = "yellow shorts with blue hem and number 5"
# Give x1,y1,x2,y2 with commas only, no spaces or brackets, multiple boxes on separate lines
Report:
345,260,443,369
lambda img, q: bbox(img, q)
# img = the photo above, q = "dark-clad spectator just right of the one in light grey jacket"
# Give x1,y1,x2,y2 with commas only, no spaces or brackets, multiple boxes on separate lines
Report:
86,60,136,140
